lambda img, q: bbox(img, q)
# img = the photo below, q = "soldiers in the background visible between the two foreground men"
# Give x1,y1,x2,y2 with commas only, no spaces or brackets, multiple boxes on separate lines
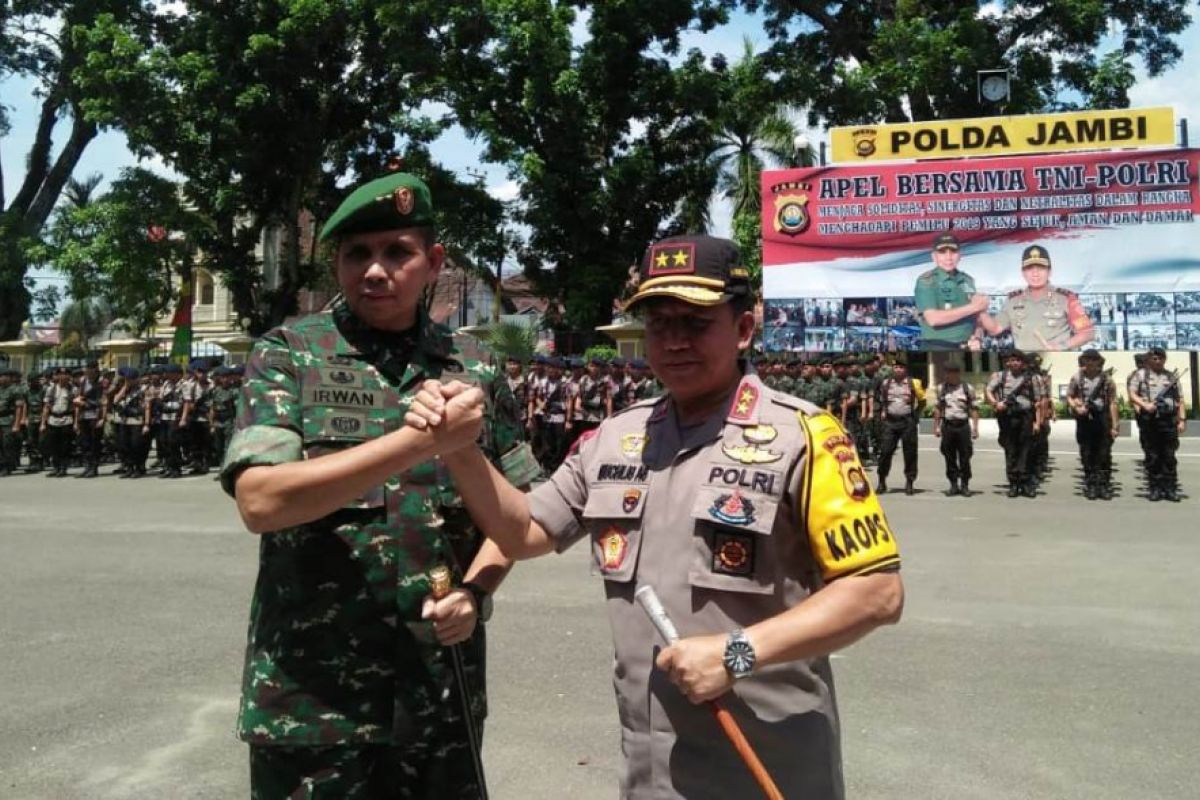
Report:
505,355,662,474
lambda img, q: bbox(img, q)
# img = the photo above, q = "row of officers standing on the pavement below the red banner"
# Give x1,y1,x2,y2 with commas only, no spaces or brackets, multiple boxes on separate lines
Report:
756,348,1187,501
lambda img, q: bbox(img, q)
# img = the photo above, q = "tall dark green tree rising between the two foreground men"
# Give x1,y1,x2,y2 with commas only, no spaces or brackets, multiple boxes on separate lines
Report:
439,0,725,329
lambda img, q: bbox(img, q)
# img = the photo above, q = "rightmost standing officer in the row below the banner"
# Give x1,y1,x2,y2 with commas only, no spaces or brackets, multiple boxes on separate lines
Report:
1129,348,1187,503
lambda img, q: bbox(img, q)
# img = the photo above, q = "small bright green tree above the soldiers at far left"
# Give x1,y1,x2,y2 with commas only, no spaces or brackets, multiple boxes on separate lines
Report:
31,168,206,333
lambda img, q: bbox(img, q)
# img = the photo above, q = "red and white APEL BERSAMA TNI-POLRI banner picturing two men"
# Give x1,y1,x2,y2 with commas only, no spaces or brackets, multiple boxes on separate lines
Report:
761,139,1200,350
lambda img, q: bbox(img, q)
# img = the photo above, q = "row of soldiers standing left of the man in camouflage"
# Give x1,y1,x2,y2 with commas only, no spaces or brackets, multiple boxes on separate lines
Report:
0,360,241,479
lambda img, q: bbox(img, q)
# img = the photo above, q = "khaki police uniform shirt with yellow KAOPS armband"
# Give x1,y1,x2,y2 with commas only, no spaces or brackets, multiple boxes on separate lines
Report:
529,374,900,800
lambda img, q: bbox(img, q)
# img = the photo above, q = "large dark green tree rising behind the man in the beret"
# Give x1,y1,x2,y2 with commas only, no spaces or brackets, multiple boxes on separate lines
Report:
72,0,468,333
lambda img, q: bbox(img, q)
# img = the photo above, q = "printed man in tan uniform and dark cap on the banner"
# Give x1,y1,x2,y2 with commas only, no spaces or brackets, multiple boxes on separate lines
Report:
979,245,1096,351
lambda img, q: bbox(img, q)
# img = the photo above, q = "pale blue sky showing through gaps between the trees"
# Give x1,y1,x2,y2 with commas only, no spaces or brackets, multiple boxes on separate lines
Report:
0,7,1200,293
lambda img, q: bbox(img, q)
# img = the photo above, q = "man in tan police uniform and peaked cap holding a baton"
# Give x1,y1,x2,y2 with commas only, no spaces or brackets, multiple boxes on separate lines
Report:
408,236,904,800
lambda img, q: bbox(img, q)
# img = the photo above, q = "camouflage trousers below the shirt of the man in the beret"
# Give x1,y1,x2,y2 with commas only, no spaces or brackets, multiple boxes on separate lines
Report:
250,732,482,800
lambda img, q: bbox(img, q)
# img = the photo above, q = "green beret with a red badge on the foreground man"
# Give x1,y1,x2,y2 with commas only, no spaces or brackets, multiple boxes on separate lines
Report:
320,173,433,241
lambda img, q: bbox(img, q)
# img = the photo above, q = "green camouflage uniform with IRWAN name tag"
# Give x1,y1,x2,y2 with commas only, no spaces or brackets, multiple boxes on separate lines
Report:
221,303,518,799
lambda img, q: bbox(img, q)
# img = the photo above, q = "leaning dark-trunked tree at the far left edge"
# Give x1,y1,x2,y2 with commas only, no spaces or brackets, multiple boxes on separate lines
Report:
0,0,149,339
